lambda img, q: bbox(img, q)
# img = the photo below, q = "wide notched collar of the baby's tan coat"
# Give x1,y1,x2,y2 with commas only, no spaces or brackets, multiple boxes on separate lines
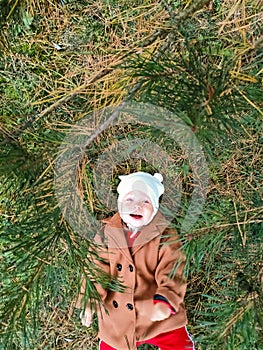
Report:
102,211,170,260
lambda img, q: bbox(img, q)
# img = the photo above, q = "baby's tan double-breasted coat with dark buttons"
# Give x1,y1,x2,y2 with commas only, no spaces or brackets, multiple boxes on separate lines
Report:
77,212,187,350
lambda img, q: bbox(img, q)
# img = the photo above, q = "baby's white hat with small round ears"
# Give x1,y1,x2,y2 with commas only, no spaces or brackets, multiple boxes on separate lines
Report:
117,171,164,215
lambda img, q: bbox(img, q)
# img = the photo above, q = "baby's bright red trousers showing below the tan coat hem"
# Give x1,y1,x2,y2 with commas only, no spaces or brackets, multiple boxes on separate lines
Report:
100,327,194,350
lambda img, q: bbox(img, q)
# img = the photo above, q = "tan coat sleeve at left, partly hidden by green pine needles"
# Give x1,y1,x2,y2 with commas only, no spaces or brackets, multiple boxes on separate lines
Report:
75,235,110,308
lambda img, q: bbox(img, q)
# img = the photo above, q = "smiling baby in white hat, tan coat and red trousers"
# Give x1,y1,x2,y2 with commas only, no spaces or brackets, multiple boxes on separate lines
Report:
77,172,194,350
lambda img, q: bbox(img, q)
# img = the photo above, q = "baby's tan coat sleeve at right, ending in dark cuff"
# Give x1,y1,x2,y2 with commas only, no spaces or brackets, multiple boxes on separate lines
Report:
155,229,186,312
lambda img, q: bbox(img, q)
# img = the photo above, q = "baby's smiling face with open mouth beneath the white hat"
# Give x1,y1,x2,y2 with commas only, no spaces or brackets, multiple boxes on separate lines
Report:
120,190,153,228
